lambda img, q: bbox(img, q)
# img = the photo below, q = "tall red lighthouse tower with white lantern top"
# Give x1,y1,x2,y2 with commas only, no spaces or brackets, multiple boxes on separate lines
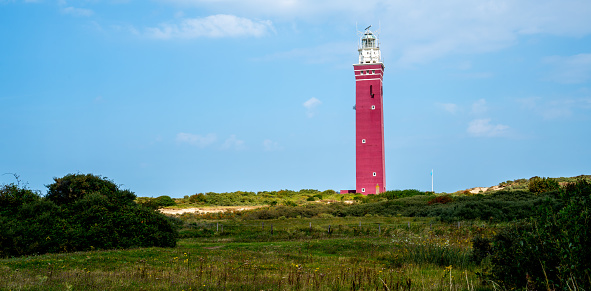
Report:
353,26,386,195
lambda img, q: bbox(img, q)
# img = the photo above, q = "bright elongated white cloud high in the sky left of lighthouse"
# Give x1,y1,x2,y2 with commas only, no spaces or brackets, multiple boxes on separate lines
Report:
147,14,274,39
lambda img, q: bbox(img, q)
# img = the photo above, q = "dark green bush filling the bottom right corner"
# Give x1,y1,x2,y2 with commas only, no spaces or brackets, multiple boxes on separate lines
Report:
491,180,591,290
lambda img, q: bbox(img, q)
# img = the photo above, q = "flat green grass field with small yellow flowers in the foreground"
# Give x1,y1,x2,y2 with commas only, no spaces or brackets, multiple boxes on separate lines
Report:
0,217,497,290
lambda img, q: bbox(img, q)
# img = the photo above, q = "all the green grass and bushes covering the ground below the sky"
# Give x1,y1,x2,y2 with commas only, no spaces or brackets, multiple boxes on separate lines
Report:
0,175,591,290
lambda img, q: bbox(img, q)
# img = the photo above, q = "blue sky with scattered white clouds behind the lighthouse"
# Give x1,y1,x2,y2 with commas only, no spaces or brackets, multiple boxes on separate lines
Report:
0,0,591,197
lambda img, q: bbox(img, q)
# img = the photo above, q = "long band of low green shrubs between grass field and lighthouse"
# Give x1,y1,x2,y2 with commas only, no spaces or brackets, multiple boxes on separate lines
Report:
179,190,560,222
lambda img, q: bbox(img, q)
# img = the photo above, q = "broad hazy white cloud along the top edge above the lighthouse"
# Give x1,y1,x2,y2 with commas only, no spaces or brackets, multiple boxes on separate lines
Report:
159,0,591,66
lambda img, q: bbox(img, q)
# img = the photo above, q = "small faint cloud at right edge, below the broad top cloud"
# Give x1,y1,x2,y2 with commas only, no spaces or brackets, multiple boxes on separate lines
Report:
543,53,591,84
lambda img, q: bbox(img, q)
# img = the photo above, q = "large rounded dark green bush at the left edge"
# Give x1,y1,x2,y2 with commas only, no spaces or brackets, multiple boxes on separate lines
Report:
0,174,177,257
